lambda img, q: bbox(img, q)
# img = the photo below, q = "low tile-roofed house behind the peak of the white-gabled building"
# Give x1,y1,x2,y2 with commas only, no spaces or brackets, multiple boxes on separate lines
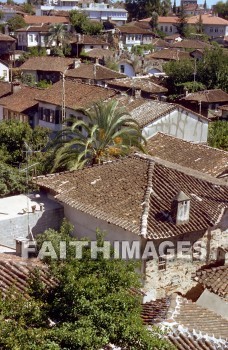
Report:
107,76,168,99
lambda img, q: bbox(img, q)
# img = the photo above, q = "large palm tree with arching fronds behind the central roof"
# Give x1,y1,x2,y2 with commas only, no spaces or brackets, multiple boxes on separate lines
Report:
52,101,146,171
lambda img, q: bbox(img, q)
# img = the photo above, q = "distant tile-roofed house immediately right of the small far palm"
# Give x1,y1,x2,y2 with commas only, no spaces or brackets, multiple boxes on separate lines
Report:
71,34,109,57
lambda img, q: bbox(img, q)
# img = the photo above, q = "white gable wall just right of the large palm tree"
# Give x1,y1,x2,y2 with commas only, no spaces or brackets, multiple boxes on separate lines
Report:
143,109,208,142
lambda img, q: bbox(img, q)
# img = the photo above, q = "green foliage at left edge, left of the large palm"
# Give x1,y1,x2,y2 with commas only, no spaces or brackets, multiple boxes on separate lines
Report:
0,120,50,197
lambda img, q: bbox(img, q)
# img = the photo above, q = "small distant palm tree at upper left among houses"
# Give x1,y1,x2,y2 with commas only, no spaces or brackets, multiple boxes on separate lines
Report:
46,23,70,47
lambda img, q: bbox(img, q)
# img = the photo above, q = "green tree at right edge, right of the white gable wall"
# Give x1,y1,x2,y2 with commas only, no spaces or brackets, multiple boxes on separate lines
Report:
208,121,228,151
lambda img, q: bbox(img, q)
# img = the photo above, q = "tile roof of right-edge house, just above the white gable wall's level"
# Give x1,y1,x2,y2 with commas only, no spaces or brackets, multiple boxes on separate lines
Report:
181,89,228,103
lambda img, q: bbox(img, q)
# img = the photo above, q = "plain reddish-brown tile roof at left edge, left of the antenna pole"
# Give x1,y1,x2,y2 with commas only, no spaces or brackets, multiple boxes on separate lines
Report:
0,86,44,113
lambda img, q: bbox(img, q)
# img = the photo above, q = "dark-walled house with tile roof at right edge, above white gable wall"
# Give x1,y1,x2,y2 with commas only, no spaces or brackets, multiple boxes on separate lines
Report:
180,89,228,118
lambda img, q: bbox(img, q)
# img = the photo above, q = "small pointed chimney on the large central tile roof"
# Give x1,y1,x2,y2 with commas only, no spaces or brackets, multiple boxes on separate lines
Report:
171,191,190,225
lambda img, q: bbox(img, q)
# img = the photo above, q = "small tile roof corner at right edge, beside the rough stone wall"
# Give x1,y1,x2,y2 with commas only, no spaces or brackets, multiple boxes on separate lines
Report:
194,266,228,301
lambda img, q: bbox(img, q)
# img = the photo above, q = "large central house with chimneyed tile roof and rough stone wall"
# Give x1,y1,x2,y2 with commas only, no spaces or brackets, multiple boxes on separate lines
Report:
36,154,228,300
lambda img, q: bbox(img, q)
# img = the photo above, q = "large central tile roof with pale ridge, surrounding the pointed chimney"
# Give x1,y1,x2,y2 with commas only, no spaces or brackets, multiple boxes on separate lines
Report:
34,154,228,239
